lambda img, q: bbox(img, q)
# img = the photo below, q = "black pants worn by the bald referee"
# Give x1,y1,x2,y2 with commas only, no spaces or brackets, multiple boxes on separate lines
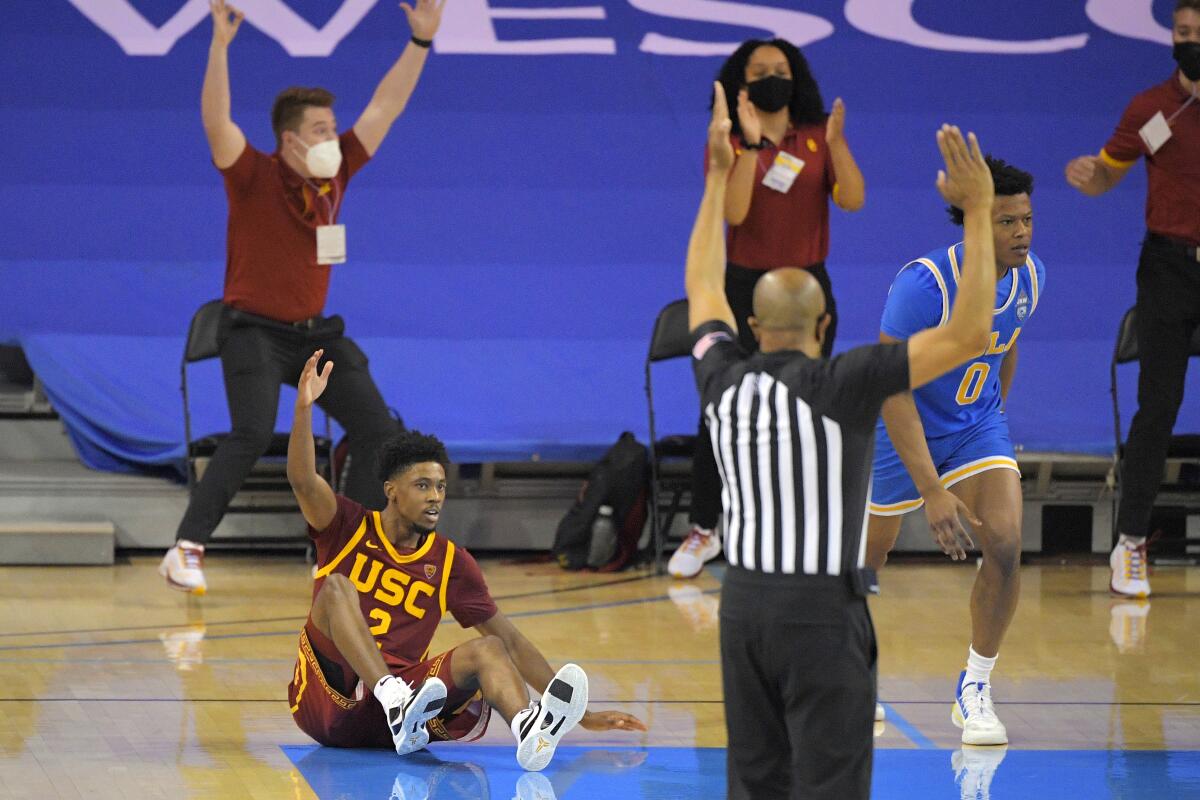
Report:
720,567,876,800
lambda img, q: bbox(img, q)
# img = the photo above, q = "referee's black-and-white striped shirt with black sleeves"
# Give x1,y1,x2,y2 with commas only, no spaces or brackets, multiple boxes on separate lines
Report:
692,320,910,576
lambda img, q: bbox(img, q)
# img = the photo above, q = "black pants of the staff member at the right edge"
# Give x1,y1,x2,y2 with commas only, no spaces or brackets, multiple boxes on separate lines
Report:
1117,234,1200,536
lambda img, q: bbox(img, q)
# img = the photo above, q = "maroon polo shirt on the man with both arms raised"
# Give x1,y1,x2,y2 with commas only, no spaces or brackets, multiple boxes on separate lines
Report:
221,130,371,323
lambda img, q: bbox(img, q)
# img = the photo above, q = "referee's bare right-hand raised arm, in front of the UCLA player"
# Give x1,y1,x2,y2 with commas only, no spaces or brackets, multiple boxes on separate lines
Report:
908,125,996,389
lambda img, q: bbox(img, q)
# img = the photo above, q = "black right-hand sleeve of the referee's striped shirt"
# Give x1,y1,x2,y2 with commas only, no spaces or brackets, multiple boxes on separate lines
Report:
829,342,910,426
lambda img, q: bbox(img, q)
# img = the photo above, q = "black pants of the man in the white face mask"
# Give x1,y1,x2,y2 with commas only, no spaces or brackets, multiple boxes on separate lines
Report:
175,312,398,543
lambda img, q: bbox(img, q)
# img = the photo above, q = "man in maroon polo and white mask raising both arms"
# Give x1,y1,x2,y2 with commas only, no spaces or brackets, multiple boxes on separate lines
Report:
158,0,445,594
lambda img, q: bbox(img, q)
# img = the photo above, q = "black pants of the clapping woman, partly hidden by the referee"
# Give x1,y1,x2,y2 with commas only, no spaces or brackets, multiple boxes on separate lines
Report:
688,261,838,530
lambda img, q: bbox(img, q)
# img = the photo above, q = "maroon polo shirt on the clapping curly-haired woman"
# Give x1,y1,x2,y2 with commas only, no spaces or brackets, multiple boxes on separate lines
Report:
704,125,836,270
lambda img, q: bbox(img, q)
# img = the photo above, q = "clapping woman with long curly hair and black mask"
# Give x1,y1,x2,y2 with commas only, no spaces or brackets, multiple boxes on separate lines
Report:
667,38,866,578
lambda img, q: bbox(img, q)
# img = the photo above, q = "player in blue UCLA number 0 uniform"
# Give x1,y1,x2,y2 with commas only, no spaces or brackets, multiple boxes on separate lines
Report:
866,157,1045,745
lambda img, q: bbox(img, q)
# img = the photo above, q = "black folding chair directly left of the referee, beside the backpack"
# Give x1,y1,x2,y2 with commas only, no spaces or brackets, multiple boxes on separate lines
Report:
646,300,696,572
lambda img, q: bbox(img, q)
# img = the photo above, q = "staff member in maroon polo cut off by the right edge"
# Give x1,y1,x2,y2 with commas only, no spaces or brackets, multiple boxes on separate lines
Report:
1067,0,1200,597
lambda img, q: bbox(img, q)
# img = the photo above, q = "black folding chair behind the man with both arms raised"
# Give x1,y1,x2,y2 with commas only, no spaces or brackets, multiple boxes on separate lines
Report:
179,300,332,513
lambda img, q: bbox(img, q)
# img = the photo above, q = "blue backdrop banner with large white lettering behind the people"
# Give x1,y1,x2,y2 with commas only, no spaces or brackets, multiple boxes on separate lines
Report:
0,0,1200,469
